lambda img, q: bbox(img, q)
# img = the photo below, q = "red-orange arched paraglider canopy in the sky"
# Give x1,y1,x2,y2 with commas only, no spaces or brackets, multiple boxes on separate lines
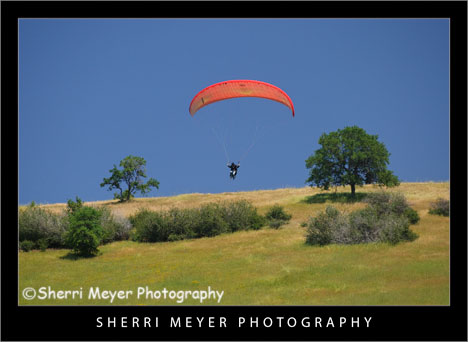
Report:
189,80,294,117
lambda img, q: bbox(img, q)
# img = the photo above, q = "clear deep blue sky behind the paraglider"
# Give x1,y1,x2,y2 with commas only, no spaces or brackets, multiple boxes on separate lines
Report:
18,19,449,204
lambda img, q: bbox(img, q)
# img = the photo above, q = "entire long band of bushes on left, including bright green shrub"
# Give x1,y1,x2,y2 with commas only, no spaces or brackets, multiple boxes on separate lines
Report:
19,197,291,256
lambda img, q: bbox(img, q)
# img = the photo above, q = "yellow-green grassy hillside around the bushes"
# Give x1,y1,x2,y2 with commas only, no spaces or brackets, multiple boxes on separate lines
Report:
19,183,449,305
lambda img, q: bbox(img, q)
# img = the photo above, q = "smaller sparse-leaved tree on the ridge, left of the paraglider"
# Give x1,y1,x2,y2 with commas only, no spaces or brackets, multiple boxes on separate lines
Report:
101,155,159,202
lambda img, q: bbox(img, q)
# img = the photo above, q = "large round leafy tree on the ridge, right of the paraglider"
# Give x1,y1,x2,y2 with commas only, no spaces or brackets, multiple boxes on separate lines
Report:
306,126,400,197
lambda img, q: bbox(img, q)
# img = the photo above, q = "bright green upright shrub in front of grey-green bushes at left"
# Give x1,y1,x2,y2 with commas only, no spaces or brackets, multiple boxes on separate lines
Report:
66,207,104,256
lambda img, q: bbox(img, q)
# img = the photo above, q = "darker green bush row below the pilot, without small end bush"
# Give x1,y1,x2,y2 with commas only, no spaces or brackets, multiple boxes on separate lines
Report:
130,200,265,242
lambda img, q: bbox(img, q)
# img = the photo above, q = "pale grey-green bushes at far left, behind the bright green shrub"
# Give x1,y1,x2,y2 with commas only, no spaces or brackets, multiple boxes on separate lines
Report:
18,197,131,254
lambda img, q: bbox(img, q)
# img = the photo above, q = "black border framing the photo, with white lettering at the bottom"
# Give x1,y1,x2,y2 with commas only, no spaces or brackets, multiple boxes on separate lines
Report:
1,1,467,341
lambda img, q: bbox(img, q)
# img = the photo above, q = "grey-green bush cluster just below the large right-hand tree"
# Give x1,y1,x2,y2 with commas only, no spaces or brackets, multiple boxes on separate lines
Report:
306,193,419,246
